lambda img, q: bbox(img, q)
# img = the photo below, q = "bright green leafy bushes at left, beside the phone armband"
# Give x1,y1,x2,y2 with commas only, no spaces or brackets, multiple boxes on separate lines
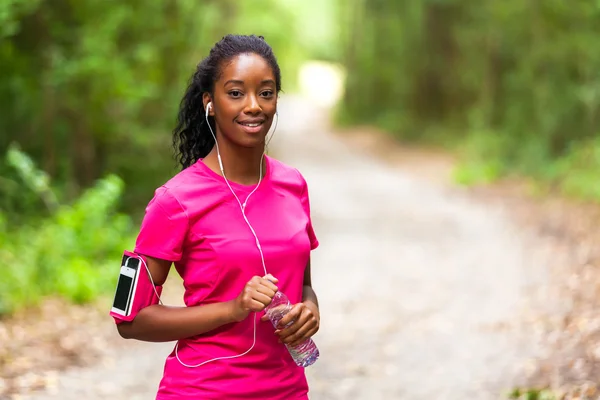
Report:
0,148,133,315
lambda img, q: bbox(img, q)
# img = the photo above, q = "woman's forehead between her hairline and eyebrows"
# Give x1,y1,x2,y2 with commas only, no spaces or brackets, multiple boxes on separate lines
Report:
217,53,275,83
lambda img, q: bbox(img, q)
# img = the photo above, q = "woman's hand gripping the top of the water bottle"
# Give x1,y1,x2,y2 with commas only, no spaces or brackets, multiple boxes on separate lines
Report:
232,274,278,322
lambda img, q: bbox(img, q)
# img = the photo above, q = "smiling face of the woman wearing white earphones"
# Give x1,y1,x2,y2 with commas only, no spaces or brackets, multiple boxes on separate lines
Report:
204,53,277,150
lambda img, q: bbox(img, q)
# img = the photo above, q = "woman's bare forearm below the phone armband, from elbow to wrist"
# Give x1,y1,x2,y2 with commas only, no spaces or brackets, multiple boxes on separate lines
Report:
118,301,236,342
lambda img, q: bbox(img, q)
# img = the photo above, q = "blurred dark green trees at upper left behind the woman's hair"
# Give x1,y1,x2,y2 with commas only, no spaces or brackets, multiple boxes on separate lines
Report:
0,0,327,212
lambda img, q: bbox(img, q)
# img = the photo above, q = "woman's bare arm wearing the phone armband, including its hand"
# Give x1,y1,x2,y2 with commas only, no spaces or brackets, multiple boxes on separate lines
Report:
117,257,277,342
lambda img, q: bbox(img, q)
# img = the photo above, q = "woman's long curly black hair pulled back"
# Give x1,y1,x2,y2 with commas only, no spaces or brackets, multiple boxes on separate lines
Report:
173,35,281,169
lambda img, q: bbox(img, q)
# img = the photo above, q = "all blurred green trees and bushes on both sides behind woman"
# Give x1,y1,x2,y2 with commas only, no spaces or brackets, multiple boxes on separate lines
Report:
0,0,600,315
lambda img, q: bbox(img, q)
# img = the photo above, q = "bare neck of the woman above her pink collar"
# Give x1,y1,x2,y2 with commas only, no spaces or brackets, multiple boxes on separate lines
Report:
204,141,266,185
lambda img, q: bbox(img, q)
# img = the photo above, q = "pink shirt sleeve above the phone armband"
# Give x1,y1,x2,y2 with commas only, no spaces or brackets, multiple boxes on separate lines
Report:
135,187,189,262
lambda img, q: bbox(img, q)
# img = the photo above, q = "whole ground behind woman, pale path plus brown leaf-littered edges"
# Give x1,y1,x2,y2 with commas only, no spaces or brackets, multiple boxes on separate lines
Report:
0,96,600,400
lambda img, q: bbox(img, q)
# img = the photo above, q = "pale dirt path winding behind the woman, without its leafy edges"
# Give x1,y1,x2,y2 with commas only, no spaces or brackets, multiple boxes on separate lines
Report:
15,98,546,400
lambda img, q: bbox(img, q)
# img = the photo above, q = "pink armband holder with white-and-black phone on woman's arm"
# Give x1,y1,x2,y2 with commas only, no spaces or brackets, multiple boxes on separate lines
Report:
110,250,162,324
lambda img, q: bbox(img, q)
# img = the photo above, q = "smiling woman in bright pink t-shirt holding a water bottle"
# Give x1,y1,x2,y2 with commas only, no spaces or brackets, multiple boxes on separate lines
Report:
118,35,319,400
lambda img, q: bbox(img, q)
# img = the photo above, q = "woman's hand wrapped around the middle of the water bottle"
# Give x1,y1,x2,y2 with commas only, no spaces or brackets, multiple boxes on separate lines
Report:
262,301,320,346
